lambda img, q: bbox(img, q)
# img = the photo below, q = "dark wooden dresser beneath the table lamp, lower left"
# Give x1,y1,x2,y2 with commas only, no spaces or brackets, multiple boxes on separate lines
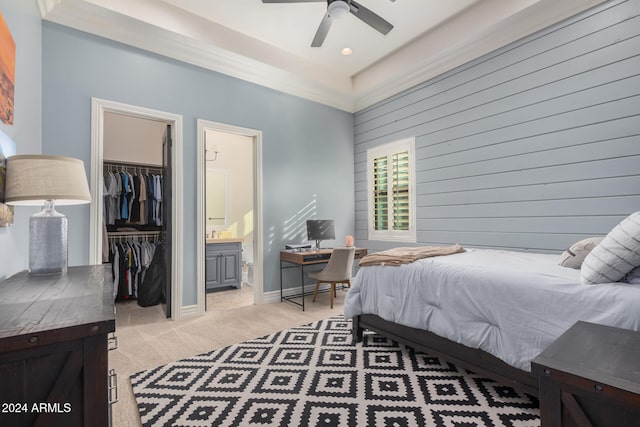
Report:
0,265,115,427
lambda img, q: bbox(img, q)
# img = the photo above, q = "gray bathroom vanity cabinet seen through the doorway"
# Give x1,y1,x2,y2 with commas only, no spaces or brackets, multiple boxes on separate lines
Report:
205,238,242,292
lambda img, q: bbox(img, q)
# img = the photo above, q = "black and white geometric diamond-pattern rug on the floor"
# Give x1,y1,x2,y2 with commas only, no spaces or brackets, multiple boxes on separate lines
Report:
130,317,540,427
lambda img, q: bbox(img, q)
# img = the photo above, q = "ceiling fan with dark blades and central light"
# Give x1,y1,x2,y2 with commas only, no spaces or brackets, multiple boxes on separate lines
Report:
262,0,393,47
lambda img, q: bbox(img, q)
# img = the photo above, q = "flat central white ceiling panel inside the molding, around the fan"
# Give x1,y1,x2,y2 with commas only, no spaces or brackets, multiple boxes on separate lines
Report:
162,0,479,76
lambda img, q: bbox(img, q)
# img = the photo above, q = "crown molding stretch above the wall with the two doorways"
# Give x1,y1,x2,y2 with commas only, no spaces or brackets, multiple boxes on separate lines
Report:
38,0,354,112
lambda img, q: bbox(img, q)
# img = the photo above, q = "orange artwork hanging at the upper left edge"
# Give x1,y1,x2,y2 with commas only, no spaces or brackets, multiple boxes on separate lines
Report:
0,13,16,125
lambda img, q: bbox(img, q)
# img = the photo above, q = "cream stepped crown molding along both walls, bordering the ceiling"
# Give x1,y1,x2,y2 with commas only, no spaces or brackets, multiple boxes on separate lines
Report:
37,0,605,112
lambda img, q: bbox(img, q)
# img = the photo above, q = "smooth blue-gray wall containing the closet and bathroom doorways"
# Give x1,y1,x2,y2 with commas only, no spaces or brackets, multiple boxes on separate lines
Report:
42,22,354,305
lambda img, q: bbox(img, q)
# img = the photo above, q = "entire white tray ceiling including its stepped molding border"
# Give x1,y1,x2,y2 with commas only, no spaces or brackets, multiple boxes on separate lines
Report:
37,0,603,111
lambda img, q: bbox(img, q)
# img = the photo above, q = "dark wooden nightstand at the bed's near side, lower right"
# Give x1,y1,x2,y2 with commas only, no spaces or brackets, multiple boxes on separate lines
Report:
531,322,640,427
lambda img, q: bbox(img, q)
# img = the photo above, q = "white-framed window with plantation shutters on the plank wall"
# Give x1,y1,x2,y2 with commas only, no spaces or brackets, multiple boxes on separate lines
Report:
367,138,416,242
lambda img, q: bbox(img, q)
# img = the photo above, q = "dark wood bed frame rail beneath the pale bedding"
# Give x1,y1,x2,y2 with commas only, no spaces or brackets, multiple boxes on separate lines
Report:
353,314,538,396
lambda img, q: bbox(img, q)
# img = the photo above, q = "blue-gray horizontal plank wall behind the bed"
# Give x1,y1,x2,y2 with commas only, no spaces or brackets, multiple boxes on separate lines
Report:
354,0,640,252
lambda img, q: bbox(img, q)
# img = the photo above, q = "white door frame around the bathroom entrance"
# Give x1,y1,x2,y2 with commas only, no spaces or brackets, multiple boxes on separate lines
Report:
196,119,264,314
